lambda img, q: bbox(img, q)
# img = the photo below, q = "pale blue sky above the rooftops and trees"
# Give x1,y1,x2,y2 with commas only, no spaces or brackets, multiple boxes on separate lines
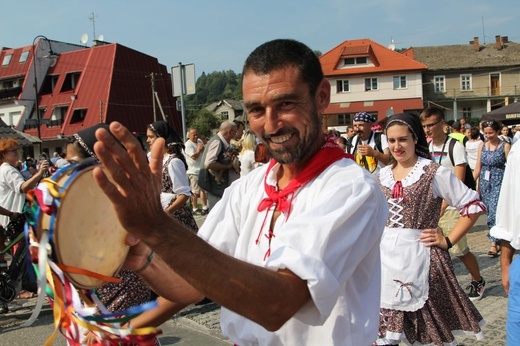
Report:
0,0,520,77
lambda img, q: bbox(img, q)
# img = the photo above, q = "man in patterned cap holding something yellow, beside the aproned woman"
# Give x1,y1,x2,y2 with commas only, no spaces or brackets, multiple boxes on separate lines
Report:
350,112,390,174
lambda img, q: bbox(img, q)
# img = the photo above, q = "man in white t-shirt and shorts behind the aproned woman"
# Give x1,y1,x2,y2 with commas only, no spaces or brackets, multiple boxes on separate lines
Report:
420,107,486,300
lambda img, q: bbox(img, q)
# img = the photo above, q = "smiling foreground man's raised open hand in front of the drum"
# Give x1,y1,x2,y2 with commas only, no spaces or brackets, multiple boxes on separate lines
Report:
94,122,168,240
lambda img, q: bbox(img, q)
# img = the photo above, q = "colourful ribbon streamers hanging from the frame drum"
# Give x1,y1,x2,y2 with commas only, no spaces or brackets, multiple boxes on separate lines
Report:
23,164,161,345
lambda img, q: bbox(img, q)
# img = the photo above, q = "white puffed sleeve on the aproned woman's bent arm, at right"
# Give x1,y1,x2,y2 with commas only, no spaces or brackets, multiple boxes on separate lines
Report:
433,166,487,216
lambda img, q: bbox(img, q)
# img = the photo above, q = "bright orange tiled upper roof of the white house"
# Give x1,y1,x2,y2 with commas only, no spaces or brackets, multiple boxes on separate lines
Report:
320,38,427,77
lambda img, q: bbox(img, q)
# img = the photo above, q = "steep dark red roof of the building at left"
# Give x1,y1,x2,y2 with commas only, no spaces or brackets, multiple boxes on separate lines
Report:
25,43,182,139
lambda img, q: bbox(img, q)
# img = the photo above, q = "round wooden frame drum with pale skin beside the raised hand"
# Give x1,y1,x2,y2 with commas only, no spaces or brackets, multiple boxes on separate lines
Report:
37,164,129,289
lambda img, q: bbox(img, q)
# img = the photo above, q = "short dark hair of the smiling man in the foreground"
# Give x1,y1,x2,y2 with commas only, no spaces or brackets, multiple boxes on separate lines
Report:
242,39,323,95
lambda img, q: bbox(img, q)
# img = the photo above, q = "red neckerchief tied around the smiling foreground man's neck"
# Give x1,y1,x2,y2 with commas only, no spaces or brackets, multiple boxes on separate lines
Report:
258,141,354,213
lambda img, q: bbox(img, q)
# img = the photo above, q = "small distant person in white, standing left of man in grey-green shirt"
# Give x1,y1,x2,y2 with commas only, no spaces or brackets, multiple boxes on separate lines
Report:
184,128,209,215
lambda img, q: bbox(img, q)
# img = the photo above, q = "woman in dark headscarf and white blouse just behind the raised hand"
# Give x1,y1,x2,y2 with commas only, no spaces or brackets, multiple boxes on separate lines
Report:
146,121,199,232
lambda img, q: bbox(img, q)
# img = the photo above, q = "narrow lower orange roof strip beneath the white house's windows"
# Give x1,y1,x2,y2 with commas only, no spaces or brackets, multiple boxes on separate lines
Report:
324,98,424,120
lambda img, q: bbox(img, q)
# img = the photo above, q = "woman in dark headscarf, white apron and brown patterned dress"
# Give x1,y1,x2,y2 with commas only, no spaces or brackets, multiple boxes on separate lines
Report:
375,113,485,345
